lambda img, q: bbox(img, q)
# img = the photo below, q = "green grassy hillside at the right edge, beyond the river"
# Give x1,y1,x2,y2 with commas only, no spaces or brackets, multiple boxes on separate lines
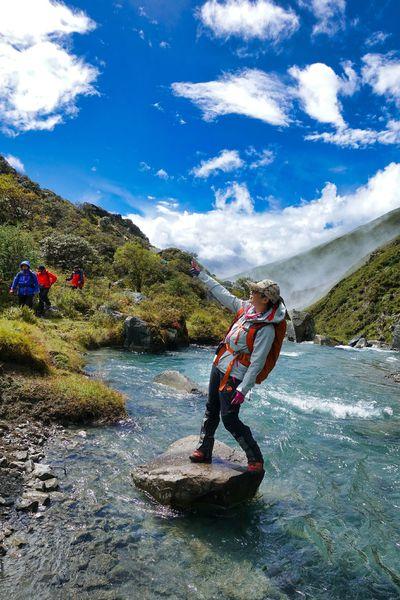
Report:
310,237,400,342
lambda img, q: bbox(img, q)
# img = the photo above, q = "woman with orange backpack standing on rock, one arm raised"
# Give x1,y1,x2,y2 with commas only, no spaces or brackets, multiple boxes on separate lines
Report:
190,260,286,472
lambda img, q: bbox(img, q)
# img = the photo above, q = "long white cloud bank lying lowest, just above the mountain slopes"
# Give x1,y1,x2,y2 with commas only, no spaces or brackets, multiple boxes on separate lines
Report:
126,163,400,276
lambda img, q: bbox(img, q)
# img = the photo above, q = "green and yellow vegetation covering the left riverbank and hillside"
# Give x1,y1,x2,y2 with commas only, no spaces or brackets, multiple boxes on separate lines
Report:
0,157,244,423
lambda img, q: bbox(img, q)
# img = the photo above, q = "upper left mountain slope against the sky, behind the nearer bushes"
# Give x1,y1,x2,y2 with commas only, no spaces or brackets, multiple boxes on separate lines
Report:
0,156,149,258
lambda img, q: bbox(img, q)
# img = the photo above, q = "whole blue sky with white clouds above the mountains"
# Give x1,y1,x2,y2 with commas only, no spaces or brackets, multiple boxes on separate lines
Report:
0,0,400,274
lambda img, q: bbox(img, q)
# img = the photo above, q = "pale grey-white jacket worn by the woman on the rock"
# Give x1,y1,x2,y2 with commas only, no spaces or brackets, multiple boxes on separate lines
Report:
199,271,286,395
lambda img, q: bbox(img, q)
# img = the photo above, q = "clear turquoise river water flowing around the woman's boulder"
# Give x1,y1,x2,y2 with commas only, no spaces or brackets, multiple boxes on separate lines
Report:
0,344,400,600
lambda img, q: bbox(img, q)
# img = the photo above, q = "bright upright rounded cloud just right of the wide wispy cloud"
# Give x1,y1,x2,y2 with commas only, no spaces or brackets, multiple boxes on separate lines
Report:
289,63,357,127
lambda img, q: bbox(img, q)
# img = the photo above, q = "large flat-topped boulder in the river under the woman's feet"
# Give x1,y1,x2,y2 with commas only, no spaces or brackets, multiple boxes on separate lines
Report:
132,435,264,510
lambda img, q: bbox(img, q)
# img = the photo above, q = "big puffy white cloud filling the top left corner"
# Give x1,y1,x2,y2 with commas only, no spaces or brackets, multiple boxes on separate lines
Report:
0,0,98,132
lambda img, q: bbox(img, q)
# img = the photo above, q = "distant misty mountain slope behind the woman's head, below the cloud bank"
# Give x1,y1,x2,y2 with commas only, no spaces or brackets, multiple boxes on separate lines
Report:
234,208,400,308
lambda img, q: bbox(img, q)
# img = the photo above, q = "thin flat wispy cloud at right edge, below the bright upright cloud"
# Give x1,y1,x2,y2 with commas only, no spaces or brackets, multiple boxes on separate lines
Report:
305,120,400,148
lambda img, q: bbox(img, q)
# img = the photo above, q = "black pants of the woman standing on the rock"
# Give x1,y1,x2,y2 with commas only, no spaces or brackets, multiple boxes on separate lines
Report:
198,365,263,461
